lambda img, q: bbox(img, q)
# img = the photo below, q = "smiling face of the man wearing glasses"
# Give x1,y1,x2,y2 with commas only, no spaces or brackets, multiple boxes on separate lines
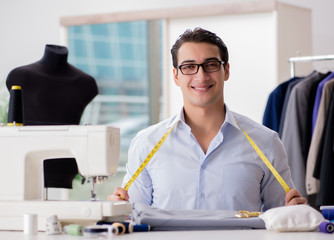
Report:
173,42,229,107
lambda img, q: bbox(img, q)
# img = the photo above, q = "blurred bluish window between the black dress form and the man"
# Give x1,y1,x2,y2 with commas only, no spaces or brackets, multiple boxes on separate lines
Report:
67,21,161,199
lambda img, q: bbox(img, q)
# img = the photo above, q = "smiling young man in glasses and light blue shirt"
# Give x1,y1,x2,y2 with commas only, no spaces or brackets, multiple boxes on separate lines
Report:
108,28,306,211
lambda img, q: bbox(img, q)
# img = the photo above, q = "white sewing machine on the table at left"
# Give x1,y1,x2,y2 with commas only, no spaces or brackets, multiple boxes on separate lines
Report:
0,125,131,231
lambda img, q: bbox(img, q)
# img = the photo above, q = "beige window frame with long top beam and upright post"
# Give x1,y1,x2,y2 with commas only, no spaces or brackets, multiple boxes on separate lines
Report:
60,0,277,119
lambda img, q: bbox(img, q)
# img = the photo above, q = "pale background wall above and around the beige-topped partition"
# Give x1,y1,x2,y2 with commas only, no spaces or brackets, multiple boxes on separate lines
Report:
0,0,334,120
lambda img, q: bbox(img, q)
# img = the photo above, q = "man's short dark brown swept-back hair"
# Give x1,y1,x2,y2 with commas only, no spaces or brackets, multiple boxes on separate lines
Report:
171,27,228,68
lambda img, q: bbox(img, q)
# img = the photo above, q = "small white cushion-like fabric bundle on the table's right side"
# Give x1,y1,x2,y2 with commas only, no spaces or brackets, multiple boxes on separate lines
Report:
259,205,325,232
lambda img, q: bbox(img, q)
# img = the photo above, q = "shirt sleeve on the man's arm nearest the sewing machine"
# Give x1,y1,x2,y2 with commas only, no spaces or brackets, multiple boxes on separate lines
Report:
122,133,153,205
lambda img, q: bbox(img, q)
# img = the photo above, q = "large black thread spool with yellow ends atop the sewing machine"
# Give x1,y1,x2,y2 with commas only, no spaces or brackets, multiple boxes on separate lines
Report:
7,85,23,126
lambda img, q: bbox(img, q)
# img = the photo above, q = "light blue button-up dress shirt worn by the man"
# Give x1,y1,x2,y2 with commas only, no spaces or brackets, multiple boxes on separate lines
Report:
123,107,294,211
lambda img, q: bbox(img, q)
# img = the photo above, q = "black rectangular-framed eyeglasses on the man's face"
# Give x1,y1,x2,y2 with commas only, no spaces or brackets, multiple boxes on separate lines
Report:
177,60,224,75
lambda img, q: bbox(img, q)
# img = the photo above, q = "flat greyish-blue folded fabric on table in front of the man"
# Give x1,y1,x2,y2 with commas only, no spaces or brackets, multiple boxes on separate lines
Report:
132,203,265,231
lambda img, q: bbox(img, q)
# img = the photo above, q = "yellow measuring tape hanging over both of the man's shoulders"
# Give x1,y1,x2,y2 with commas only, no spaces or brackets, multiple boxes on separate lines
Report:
121,121,290,196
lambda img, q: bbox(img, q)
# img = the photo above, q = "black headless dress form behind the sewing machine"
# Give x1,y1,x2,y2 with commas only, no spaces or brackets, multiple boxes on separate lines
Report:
6,45,98,125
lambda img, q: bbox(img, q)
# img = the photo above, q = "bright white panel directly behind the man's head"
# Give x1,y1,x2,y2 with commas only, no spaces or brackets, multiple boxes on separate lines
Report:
165,11,277,122
